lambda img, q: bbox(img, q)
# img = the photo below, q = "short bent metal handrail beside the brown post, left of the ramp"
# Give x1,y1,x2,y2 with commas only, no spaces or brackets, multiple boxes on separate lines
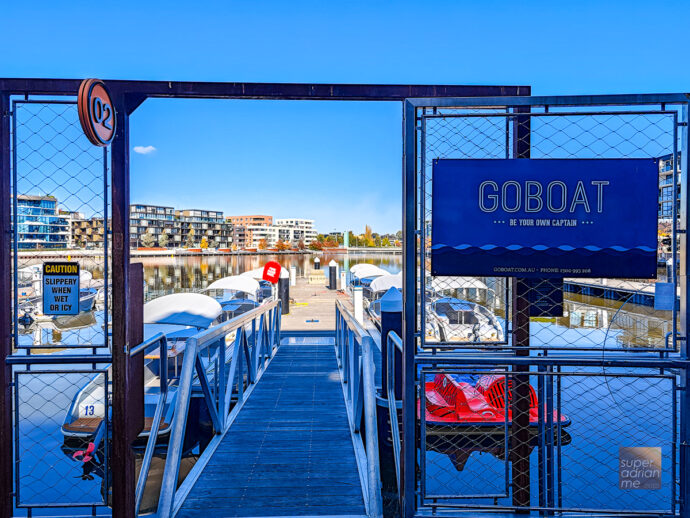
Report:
129,333,168,515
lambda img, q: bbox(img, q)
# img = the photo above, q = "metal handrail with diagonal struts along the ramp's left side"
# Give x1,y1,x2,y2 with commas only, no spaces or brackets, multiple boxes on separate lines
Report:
157,300,281,518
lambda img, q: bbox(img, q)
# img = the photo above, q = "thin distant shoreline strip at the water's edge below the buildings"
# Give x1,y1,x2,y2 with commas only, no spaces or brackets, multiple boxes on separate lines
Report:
19,246,402,259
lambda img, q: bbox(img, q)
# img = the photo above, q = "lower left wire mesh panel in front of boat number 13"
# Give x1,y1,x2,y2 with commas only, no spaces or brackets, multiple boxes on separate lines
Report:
14,370,109,507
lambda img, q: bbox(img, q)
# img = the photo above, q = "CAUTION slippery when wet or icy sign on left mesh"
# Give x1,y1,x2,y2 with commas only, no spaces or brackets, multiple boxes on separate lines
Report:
43,263,79,315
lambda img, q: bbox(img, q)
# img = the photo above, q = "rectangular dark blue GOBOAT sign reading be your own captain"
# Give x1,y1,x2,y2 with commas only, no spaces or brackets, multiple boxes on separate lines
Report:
431,159,658,278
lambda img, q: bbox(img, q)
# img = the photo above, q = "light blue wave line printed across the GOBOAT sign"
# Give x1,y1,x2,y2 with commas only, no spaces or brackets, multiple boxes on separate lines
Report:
431,243,656,256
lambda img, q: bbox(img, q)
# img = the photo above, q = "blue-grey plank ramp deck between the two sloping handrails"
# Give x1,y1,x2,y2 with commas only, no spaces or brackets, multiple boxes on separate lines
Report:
177,340,366,518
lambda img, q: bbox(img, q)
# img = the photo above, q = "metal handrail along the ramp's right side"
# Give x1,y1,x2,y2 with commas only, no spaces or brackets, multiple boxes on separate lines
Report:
335,300,383,518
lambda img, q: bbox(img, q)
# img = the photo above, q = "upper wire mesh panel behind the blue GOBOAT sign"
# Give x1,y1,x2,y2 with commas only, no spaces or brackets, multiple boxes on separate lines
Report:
417,107,679,351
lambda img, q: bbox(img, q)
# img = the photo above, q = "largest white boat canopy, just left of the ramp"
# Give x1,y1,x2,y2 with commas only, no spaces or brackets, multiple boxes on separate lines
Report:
144,293,223,327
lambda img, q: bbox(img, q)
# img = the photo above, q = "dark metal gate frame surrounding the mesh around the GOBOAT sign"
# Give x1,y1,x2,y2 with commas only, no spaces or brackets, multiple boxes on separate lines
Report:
401,94,690,518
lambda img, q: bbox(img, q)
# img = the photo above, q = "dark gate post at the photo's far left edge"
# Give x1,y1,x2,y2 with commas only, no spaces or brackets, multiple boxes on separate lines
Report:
0,92,14,518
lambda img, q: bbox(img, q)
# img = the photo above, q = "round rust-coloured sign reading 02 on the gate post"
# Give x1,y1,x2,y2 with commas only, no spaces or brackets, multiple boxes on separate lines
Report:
77,79,115,147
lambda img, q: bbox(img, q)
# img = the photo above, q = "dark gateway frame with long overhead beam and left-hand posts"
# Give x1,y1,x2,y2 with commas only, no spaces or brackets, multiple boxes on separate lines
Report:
0,78,531,518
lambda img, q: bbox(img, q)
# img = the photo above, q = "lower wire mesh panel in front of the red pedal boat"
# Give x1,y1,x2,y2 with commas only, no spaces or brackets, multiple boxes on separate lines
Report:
420,365,679,514
